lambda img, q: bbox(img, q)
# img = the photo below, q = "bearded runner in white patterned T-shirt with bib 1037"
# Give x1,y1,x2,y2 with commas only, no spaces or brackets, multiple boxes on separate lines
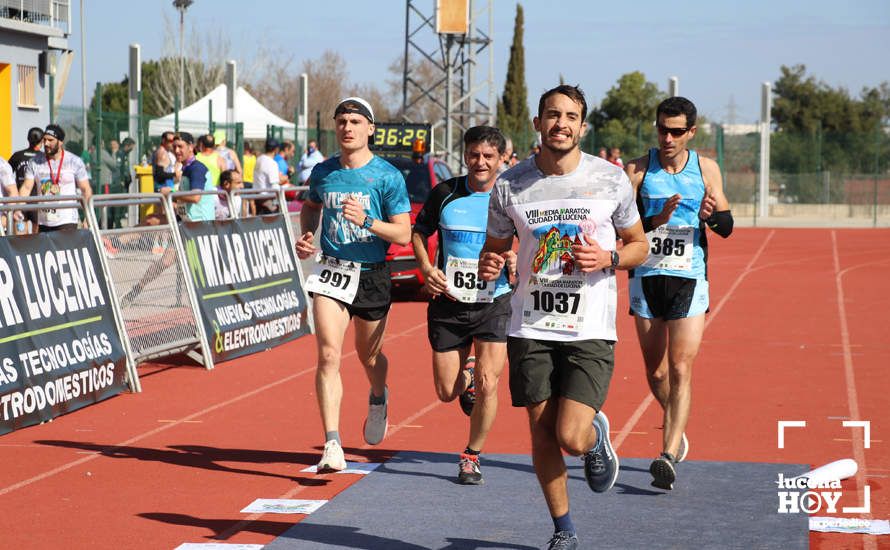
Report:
479,86,648,549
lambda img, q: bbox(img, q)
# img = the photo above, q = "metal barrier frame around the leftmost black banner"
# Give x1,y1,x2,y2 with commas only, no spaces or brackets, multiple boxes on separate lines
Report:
0,195,142,392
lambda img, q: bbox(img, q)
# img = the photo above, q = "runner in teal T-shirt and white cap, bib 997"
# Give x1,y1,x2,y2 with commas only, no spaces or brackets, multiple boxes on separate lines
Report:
297,97,411,471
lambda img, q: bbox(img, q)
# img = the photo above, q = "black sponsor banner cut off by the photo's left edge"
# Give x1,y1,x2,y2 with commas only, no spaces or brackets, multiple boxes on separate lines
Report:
0,229,127,434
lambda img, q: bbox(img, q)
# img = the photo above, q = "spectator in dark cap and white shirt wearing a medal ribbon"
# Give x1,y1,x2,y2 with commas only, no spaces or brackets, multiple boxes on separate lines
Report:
20,124,93,233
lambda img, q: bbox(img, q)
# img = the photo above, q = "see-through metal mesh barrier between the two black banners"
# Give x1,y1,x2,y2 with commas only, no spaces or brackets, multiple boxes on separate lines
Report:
90,193,213,369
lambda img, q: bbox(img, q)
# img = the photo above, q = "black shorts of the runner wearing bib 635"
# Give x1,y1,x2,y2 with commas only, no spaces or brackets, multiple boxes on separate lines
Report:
426,292,510,352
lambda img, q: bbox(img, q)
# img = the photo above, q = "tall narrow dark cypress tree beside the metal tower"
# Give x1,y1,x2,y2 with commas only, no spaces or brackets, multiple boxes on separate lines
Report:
497,4,534,151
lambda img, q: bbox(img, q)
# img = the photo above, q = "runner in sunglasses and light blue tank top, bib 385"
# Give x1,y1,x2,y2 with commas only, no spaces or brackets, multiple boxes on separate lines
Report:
627,97,732,490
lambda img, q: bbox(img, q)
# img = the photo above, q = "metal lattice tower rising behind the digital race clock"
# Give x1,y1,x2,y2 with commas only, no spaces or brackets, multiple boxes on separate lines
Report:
401,0,496,171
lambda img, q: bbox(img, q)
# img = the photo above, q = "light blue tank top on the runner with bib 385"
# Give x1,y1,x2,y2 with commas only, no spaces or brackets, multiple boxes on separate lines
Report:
634,148,707,279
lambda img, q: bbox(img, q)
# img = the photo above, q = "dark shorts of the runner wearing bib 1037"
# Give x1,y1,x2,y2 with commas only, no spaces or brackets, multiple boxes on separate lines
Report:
507,336,615,411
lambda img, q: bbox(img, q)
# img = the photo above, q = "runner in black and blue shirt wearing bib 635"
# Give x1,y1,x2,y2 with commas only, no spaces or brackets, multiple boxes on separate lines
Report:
411,126,515,485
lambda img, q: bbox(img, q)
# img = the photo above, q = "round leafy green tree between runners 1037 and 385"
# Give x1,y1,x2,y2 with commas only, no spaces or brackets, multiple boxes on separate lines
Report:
587,71,665,158
